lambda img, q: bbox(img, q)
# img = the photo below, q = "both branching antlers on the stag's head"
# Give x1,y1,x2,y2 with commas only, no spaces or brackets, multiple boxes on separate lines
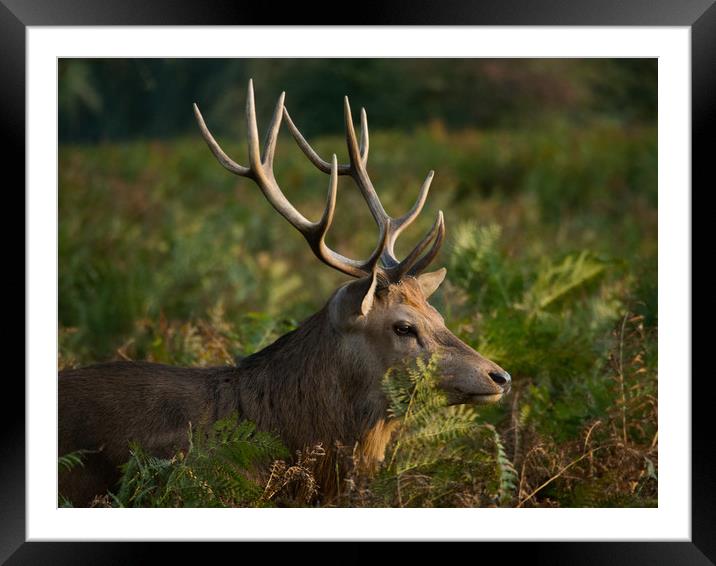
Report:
194,80,445,281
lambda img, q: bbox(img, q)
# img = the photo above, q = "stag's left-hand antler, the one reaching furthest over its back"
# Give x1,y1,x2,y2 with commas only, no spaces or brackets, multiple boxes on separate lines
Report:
194,80,388,277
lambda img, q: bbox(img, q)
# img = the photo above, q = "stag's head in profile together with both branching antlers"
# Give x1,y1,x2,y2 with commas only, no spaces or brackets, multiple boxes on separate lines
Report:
194,81,510,404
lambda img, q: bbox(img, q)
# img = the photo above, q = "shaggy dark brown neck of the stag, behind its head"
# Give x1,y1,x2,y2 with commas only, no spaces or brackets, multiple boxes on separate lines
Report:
238,308,386,450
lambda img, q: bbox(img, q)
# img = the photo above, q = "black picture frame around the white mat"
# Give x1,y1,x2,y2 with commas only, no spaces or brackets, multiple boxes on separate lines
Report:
5,0,716,565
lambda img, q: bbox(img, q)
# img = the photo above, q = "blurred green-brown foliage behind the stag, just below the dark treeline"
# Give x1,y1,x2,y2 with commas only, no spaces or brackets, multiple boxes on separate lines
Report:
59,123,656,364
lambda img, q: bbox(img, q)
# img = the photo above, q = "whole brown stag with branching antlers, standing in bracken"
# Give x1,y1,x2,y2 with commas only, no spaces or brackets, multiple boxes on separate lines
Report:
58,80,511,505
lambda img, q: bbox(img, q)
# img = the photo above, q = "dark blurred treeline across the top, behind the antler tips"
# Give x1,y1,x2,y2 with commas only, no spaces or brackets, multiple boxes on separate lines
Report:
58,58,657,142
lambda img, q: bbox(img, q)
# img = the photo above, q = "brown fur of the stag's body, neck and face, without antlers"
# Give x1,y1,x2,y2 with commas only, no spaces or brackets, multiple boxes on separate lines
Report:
59,278,510,505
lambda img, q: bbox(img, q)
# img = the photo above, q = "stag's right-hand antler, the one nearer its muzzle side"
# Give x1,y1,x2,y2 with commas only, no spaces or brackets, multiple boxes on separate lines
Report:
283,96,445,281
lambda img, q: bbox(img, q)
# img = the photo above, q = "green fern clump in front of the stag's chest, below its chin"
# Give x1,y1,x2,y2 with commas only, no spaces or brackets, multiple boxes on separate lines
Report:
373,356,516,506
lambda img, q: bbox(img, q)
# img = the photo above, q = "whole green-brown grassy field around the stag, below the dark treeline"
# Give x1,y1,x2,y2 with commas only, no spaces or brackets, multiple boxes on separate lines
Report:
59,117,658,507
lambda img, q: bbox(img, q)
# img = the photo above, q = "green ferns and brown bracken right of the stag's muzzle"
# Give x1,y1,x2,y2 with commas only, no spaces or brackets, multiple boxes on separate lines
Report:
452,226,657,506
